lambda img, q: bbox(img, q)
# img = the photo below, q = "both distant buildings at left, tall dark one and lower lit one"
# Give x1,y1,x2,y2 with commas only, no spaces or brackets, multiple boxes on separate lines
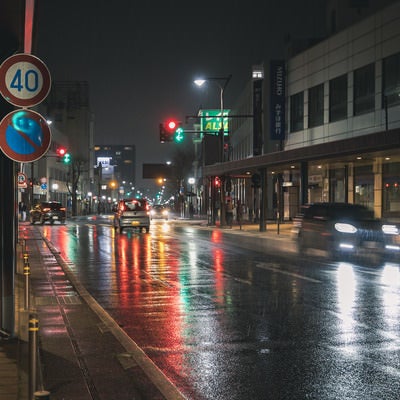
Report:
26,81,136,211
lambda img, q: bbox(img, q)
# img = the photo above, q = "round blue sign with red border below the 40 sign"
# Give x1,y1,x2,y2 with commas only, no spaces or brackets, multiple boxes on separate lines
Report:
0,110,51,162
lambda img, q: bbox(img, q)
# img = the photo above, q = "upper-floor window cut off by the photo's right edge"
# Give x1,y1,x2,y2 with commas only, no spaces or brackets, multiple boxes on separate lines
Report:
382,53,400,108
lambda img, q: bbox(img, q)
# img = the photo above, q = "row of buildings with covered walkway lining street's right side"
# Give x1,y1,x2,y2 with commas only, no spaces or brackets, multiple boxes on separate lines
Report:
204,2,400,220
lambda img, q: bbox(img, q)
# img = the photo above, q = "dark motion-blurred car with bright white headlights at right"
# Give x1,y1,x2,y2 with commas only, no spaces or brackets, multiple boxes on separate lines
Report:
294,203,400,257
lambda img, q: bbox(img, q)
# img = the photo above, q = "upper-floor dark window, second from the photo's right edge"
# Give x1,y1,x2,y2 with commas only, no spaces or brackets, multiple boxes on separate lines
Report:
354,64,375,115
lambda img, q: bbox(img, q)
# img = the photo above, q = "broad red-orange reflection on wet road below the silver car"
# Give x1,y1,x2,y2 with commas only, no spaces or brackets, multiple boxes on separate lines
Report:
115,235,188,380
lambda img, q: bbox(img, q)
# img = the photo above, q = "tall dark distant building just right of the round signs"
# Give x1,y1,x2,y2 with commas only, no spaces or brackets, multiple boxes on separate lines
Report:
32,81,94,214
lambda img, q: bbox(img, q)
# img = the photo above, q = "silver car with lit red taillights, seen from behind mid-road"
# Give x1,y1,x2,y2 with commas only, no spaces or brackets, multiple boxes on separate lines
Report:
114,199,150,233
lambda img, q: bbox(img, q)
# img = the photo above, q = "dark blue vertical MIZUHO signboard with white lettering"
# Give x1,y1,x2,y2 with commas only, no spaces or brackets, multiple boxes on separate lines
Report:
269,60,285,140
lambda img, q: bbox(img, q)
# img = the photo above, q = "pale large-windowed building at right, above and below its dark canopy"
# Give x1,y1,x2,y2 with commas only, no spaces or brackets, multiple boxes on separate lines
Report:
285,3,400,217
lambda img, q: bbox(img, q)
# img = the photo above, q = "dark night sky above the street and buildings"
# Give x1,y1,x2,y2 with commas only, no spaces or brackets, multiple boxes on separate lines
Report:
35,0,324,188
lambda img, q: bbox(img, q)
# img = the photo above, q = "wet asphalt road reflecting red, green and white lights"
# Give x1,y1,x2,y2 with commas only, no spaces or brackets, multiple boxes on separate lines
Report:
40,220,400,400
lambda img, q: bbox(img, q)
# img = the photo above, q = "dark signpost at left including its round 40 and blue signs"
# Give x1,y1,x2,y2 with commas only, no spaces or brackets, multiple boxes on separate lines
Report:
0,52,51,334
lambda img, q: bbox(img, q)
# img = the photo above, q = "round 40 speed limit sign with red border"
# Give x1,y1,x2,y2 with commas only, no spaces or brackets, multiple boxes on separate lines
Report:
0,53,51,107
